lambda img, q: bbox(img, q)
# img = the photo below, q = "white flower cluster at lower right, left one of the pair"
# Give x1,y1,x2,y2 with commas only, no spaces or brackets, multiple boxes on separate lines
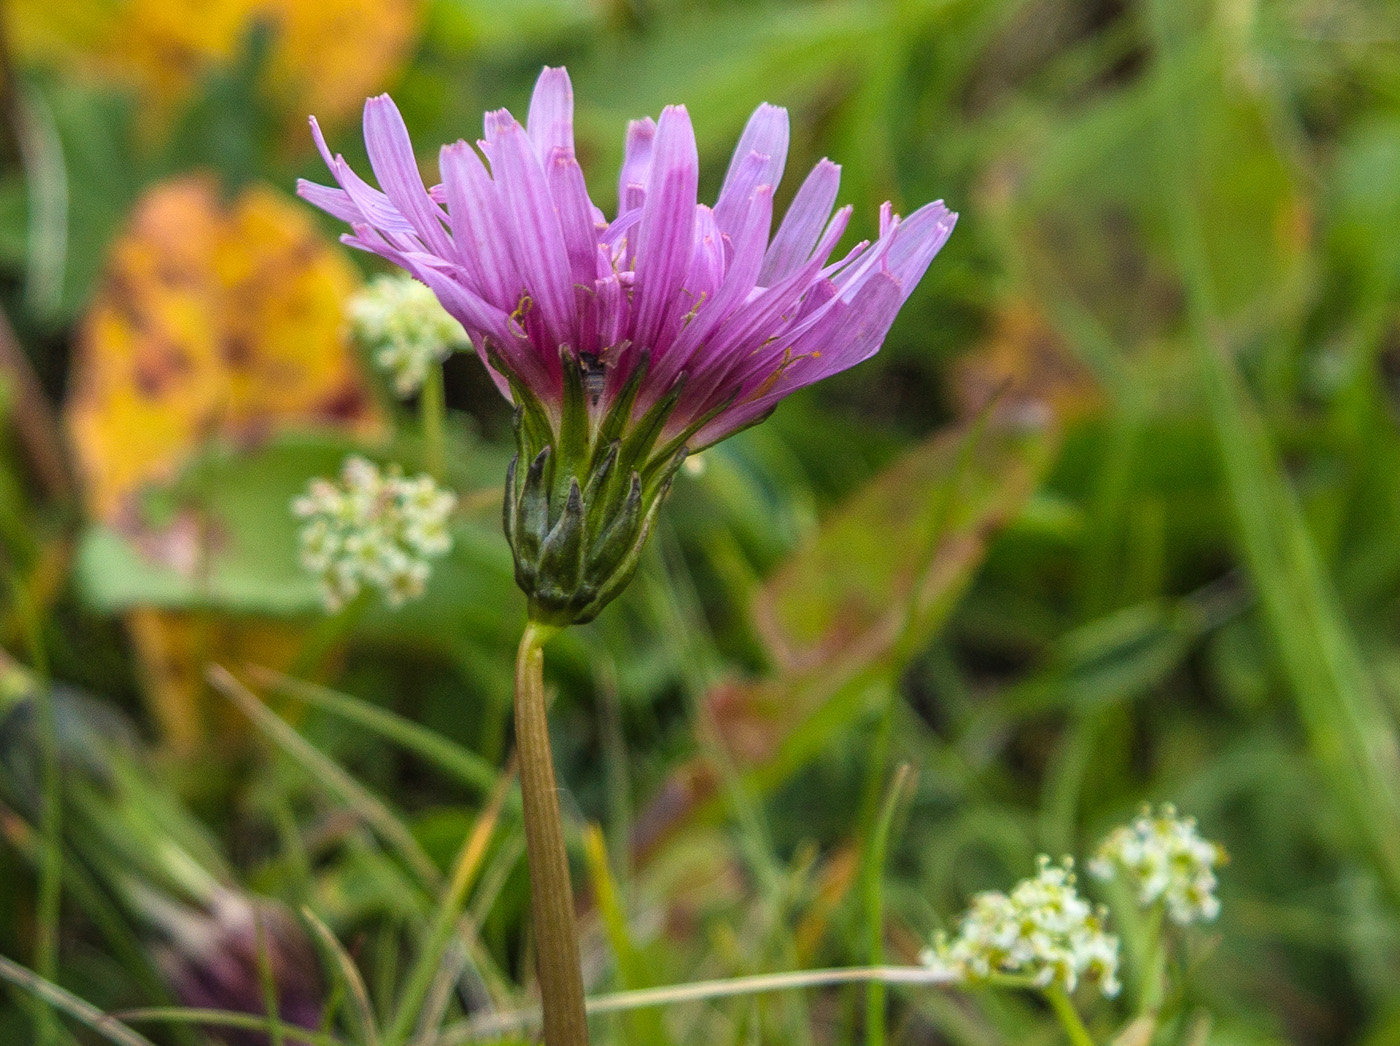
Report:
924,857,1120,997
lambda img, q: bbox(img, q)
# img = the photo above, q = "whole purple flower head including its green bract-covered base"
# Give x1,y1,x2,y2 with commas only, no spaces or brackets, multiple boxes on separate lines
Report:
298,69,956,625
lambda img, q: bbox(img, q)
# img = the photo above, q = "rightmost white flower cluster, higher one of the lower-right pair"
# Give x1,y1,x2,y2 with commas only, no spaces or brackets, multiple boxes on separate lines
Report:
1089,804,1225,926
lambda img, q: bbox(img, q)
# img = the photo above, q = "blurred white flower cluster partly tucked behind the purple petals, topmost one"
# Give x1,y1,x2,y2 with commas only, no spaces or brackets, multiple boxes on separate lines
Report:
347,276,469,396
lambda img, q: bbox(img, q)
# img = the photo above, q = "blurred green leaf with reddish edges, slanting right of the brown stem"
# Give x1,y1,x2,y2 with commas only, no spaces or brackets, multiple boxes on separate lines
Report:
637,427,1058,850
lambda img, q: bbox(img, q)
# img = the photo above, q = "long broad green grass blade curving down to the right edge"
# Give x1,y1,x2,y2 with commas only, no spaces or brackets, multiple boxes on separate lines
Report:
1151,0,1400,903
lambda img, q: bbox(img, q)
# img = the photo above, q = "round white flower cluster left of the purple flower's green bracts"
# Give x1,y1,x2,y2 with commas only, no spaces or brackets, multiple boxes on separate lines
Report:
291,456,456,611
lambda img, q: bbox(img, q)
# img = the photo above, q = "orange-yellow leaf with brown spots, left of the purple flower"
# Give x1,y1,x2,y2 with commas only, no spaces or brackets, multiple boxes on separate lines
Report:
66,176,381,524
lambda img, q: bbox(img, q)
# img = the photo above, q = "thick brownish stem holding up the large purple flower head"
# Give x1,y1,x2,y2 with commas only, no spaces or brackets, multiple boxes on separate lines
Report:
515,622,588,1046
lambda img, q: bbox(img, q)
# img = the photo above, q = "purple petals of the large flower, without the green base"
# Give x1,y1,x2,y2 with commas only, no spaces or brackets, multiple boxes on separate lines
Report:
298,69,956,449
